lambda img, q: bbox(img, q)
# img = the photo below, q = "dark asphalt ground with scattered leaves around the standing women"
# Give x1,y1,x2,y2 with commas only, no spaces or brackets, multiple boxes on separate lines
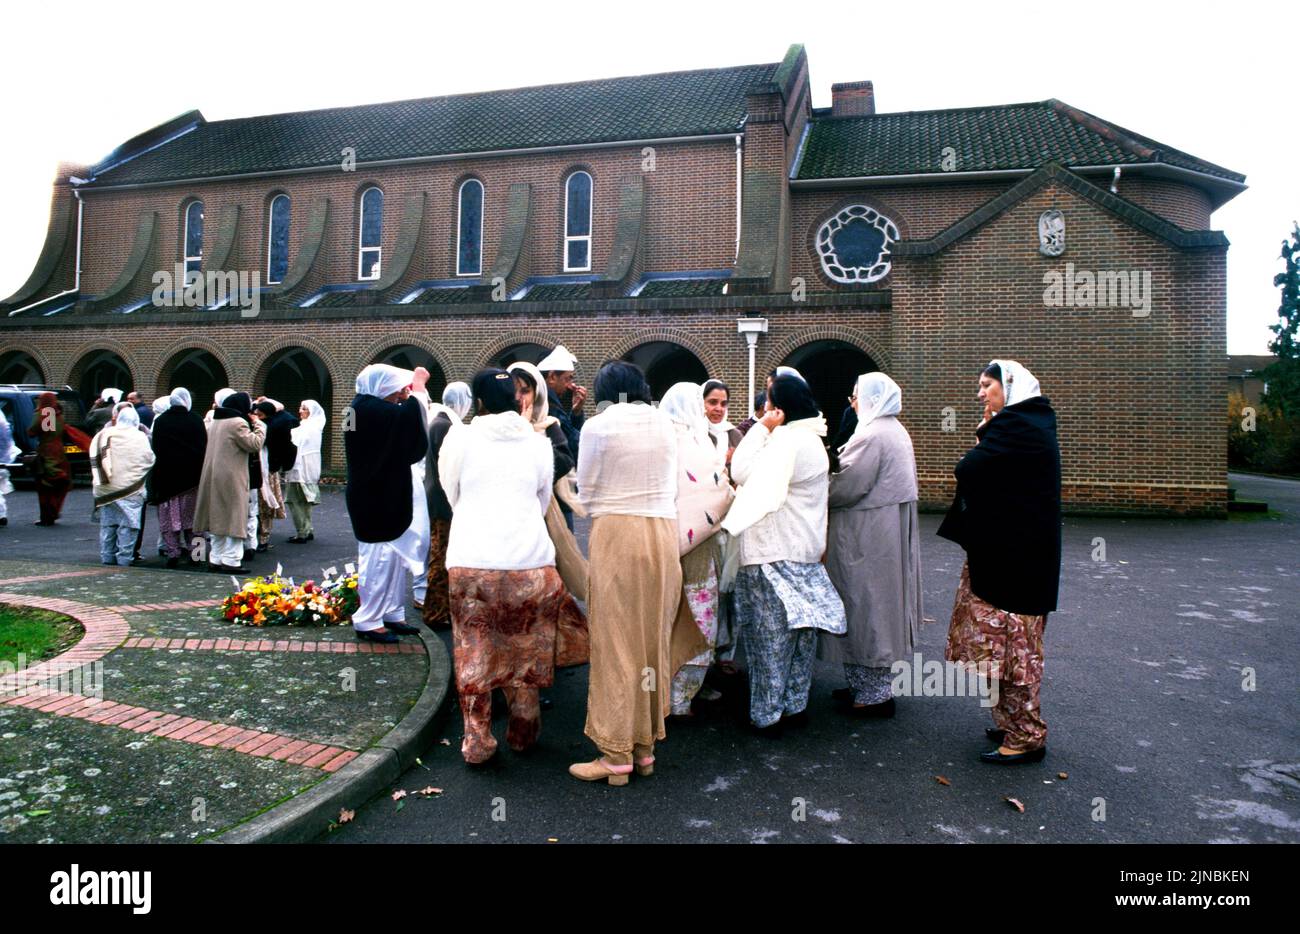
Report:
0,475,1300,843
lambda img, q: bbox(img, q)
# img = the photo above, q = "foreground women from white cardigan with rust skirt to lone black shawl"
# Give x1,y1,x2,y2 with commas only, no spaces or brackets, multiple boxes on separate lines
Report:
350,360,1060,784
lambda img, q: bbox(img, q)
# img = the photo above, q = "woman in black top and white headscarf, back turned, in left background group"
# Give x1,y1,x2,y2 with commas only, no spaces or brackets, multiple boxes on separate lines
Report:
150,388,208,567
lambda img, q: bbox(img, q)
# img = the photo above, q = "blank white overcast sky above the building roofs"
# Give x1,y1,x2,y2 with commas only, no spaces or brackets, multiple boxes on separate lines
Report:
0,0,1300,354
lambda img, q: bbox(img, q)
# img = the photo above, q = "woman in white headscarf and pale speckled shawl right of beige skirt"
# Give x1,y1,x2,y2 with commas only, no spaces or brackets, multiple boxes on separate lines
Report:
659,382,735,718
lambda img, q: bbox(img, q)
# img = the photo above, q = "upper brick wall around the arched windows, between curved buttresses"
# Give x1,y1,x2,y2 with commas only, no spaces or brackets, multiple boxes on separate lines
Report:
82,140,736,298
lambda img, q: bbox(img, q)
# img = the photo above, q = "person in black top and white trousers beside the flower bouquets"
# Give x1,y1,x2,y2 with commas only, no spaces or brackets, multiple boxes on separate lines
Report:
343,363,429,643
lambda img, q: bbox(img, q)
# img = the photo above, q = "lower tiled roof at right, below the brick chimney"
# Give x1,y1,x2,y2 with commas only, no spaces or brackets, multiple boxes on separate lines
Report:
796,100,1245,182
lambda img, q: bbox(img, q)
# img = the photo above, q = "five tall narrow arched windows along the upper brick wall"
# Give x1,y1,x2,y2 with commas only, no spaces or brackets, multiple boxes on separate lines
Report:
181,169,593,285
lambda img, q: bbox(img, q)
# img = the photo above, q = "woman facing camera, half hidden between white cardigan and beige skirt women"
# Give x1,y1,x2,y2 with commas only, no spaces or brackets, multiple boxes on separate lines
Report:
506,362,590,666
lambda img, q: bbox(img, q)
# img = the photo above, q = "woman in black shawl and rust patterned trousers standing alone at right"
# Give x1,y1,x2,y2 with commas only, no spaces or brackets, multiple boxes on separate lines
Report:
939,360,1061,765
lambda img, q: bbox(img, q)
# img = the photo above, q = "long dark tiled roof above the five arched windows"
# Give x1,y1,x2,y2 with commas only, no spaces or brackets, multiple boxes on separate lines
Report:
94,62,779,185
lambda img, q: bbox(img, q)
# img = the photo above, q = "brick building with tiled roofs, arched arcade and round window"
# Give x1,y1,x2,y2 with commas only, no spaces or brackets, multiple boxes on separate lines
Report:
0,46,1244,515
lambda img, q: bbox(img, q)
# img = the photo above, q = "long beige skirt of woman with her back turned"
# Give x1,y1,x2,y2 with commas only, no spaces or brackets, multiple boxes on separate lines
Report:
585,515,681,754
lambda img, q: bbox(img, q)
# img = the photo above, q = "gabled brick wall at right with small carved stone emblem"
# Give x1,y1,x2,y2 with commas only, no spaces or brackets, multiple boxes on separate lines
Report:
892,180,1226,514
